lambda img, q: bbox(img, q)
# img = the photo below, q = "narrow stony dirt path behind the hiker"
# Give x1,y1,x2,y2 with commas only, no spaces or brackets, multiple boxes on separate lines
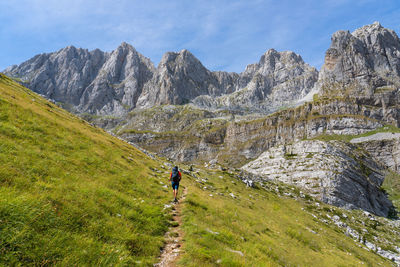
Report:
154,188,187,267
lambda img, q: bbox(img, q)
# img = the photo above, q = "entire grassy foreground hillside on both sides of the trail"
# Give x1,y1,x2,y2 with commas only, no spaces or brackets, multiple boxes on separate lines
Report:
0,74,399,266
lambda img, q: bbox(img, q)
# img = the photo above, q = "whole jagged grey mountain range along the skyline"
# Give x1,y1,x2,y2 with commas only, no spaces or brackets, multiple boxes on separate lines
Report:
4,22,400,118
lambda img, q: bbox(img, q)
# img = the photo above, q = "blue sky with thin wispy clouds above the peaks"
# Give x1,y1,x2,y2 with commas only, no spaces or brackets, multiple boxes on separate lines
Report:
0,0,400,72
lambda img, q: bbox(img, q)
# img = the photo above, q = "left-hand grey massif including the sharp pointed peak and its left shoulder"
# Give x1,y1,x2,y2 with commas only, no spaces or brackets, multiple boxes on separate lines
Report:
4,43,154,116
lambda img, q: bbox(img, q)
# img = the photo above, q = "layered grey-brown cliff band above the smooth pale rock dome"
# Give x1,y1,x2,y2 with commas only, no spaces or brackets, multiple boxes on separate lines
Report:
218,100,386,165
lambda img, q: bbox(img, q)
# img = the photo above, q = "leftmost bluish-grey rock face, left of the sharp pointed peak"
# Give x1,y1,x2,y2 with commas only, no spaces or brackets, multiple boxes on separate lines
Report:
4,46,108,106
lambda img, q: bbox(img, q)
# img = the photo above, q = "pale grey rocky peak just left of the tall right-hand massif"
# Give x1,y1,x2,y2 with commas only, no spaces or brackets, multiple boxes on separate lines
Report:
193,49,318,113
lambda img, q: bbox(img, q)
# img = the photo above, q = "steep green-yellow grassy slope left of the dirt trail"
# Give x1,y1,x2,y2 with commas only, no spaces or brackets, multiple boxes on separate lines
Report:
0,74,169,266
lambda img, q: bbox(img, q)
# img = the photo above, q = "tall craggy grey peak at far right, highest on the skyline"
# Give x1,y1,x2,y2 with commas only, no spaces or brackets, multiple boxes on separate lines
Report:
317,22,400,96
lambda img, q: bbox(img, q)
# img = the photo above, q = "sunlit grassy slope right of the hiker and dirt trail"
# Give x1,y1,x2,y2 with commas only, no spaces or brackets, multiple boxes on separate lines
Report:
180,171,399,266
